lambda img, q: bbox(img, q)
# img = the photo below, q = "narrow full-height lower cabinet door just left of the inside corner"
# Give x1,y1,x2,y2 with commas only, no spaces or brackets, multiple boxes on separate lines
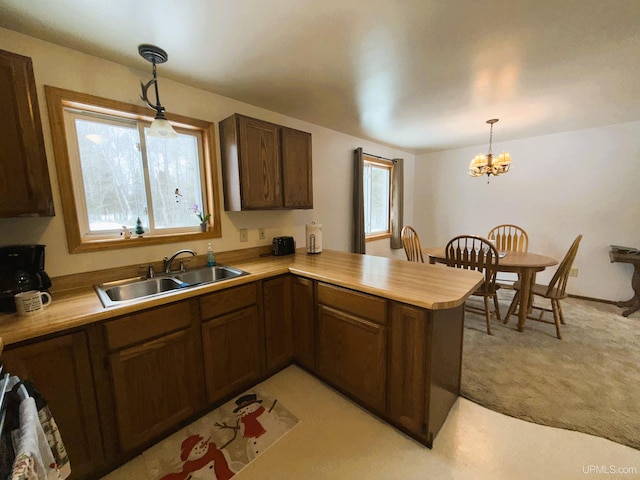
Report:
262,275,293,372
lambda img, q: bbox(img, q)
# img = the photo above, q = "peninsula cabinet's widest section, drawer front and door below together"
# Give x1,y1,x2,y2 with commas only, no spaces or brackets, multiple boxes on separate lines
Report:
317,284,387,412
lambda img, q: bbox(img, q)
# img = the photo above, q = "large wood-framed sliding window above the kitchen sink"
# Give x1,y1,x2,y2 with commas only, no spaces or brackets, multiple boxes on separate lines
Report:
46,86,220,253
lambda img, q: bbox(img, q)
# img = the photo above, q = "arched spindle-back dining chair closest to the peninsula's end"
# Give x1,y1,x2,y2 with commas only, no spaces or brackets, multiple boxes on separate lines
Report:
445,235,500,335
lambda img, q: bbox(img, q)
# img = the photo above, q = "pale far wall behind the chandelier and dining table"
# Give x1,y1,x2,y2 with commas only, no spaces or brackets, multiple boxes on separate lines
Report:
415,124,640,300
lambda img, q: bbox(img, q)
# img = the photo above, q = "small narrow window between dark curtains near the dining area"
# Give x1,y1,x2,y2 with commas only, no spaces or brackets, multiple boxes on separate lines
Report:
363,154,393,240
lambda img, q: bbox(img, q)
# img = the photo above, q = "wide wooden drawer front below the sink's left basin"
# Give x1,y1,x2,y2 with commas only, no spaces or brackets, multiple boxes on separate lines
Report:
104,301,192,350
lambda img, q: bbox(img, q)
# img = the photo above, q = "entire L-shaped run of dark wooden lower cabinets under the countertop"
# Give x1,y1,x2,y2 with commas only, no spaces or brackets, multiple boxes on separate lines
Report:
3,275,464,478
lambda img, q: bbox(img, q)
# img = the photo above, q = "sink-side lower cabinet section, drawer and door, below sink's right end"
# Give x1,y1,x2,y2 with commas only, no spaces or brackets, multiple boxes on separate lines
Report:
200,283,264,403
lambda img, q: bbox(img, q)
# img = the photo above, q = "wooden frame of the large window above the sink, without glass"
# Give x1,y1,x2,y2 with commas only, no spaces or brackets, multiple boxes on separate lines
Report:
45,85,222,253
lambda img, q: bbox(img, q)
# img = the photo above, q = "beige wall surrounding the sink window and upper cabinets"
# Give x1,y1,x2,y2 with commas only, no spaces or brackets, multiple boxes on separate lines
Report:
0,29,414,276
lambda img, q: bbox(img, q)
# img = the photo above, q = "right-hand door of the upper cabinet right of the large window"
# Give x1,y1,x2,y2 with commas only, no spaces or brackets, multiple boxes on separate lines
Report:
281,127,313,208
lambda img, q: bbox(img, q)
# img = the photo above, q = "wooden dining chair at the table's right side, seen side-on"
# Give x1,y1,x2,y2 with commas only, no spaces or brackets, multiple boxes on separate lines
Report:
504,235,582,339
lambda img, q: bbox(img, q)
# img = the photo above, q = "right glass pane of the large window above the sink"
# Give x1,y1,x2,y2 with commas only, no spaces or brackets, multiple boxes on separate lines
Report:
145,128,202,229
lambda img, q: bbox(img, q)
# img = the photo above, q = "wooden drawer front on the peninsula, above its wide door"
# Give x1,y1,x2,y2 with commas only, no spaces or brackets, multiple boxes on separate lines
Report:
318,283,387,325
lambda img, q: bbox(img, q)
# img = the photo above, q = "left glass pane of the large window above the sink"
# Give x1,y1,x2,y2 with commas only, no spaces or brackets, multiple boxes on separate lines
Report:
75,118,146,232
